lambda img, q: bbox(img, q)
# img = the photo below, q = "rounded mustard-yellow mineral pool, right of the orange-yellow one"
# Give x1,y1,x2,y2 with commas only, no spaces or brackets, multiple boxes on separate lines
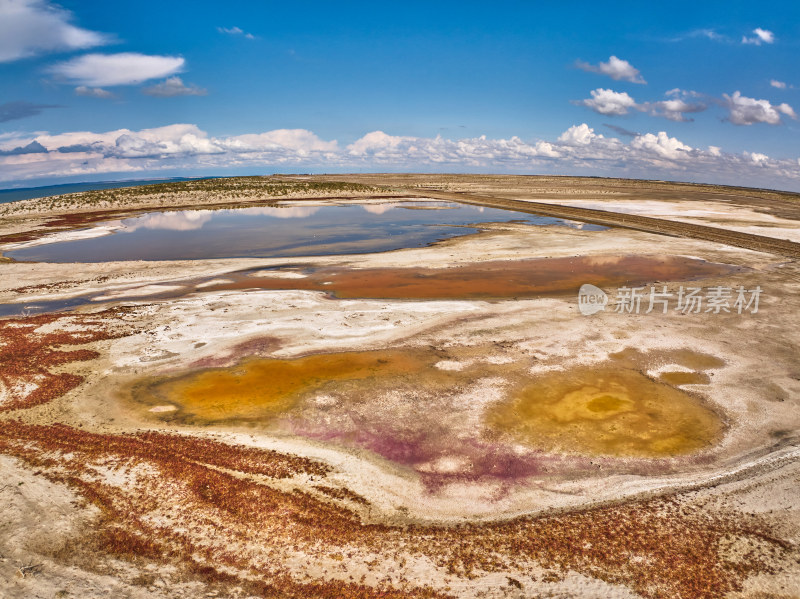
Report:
487,366,723,457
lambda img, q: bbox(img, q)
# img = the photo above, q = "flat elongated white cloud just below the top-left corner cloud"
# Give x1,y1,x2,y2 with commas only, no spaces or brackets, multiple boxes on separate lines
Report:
50,52,185,87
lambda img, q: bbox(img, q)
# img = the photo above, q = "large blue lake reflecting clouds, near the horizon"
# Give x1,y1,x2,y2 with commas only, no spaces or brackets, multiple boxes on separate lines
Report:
4,202,600,262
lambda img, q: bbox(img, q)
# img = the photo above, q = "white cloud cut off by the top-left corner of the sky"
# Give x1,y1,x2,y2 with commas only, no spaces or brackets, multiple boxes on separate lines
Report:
0,0,111,62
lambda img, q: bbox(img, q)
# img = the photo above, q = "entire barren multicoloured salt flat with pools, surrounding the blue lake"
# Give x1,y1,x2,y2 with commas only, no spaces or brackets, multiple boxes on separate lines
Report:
0,174,800,599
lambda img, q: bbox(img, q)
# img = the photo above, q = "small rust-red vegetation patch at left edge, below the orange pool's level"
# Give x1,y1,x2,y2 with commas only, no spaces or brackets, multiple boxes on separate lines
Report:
0,309,134,412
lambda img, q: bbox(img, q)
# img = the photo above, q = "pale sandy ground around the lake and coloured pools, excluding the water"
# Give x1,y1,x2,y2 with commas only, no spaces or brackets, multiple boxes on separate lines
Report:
0,175,800,598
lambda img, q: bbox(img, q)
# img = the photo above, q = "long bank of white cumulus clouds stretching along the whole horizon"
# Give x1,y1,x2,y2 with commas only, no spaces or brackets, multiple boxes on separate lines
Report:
0,123,800,190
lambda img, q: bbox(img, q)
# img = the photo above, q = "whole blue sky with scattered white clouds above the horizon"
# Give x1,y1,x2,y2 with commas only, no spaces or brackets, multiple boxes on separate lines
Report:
0,0,800,190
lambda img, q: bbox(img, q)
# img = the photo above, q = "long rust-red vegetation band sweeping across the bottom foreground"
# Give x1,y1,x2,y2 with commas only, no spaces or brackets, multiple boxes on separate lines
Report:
0,421,794,599
